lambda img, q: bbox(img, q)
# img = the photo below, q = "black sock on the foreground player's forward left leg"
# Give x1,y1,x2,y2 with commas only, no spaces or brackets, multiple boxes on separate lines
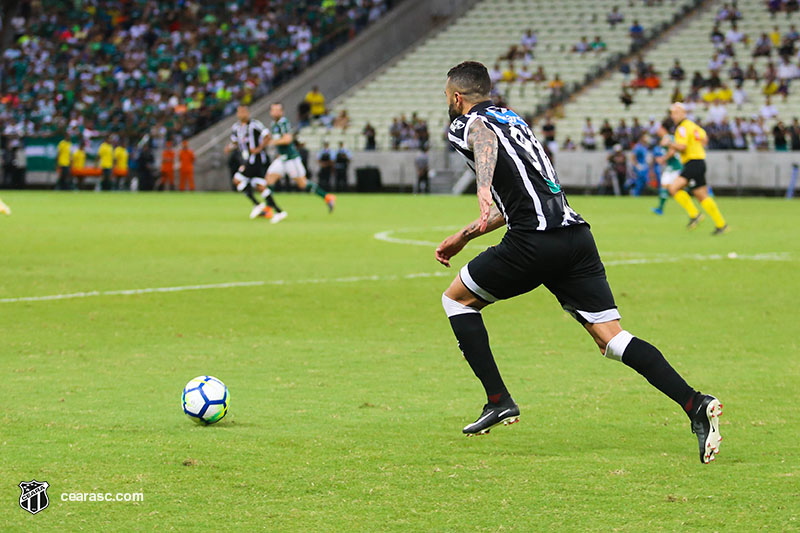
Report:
450,313,509,403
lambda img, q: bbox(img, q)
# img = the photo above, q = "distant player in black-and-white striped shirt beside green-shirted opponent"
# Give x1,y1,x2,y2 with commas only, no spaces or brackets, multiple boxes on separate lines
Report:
225,105,281,218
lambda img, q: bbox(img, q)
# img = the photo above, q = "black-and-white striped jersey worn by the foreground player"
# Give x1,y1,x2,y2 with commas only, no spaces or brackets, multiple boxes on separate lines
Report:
447,101,586,231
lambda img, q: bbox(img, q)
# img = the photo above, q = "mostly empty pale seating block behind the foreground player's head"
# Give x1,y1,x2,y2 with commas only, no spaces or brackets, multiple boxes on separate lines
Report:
303,0,697,150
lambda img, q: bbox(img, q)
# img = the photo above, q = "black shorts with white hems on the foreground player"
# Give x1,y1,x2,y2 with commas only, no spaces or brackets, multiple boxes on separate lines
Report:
459,224,620,324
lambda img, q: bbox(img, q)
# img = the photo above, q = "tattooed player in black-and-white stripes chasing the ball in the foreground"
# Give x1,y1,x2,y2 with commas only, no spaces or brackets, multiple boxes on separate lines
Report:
436,61,722,463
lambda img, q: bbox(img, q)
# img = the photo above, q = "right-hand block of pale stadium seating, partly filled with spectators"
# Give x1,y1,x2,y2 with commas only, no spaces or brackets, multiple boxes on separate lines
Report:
558,0,800,149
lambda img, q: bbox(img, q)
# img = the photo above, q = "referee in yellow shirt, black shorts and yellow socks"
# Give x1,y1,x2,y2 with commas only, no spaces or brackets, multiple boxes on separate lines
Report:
664,102,728,235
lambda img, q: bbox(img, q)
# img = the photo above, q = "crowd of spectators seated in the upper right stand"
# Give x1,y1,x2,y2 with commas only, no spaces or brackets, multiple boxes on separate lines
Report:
596,1,800,150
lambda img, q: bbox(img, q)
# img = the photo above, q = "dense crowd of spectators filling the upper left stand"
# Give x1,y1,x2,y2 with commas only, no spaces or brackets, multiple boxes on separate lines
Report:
0,0,394,183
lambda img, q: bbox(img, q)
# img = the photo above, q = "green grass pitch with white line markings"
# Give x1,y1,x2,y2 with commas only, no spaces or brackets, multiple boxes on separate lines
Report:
0,192,800,532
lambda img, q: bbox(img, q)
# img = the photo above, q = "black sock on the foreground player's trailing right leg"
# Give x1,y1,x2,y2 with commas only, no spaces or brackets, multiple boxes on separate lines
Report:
622,337,696,411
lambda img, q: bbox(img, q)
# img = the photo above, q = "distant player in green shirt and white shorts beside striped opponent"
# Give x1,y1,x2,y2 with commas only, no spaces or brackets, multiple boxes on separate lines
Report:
267,103,336,222
